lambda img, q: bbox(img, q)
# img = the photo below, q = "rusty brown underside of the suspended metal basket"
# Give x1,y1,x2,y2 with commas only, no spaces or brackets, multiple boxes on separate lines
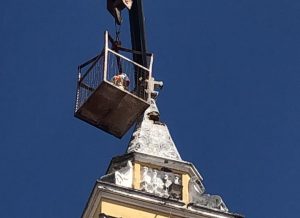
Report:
75,81,149,138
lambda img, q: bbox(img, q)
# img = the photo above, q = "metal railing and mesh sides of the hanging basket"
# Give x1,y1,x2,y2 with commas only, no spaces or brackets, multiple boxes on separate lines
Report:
75,31,153,111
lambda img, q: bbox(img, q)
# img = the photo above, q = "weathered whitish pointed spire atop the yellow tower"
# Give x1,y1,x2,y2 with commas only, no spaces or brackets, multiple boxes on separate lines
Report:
127,99,182,161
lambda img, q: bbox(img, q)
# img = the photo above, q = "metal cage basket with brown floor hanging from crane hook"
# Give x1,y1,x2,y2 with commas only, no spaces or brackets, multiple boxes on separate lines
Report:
75,32,152,138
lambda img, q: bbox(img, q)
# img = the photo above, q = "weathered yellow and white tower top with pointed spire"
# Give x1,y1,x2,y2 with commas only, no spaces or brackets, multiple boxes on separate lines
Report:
82,100,242,218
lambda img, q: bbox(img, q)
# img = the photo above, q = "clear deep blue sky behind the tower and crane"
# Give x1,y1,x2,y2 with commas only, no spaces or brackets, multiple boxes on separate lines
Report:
0,0,300,218
